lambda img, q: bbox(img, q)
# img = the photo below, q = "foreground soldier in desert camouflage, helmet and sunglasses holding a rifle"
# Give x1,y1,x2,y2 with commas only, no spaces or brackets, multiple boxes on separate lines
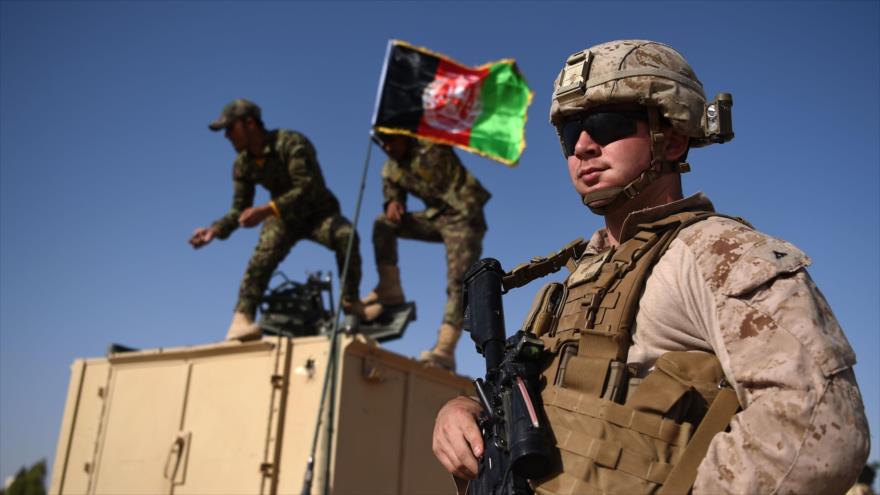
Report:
434,40,869,494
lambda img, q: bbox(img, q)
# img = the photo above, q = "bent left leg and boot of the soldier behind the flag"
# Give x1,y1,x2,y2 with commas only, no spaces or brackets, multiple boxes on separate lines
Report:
363,212,443,305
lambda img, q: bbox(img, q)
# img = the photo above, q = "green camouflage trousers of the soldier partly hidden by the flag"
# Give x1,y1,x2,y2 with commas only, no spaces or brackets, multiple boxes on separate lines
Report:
373,211,487,328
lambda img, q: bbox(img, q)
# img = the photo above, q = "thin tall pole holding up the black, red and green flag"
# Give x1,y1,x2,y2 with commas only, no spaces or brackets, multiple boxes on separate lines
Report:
301,40,394,495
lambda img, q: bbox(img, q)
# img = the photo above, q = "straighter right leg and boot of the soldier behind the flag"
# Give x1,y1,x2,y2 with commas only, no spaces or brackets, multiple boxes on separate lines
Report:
420,214,486,371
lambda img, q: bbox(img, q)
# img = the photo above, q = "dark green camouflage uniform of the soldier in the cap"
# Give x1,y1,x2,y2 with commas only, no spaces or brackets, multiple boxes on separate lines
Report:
212,129,361,317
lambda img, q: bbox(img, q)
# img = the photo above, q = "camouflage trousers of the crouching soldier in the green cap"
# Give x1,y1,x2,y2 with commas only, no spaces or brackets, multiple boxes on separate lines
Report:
235,212,361,318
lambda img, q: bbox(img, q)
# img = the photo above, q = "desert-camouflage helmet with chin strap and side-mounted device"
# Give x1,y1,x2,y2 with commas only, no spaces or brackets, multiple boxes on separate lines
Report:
550,40,733,214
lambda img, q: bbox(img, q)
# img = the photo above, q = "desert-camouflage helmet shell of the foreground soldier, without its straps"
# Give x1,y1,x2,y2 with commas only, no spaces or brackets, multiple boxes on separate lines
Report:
550,40,706,139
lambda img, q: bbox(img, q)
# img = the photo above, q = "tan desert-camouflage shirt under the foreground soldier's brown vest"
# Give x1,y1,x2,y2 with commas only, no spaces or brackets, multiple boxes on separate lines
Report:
587,194,869,494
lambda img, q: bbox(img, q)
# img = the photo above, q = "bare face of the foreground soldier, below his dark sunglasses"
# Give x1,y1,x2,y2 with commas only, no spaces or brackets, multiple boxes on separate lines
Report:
568,121,651,202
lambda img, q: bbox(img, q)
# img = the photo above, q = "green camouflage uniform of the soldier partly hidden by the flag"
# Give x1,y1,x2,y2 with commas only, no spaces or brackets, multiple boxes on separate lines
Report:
373,141,491,327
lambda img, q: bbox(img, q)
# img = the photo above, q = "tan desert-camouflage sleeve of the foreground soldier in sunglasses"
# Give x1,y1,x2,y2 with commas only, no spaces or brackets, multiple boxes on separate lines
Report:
679,219,869,494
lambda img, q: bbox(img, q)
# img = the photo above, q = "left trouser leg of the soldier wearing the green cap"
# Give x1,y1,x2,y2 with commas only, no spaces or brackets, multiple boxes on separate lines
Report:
235,217,298,319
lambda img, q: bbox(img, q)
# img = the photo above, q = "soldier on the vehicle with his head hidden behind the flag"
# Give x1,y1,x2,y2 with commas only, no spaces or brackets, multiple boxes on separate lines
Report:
363,134,491,371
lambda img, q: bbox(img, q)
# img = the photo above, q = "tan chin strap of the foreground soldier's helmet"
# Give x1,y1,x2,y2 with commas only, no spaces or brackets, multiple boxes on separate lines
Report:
581,107,691,215
